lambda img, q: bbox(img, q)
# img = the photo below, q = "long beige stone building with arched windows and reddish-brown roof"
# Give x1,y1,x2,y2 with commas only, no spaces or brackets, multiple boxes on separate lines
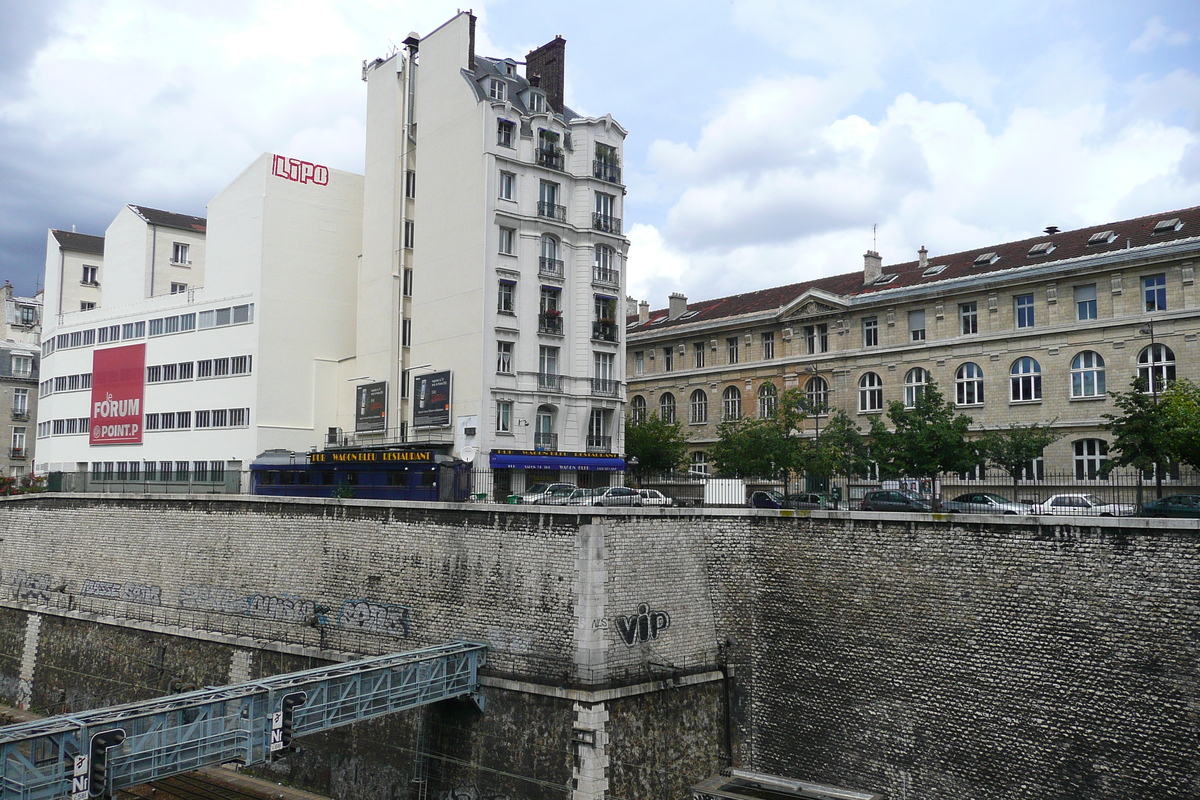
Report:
626,207,1200,480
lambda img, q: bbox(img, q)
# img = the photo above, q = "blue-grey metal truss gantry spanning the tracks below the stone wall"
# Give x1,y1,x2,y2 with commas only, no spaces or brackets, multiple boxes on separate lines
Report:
0,642,487,800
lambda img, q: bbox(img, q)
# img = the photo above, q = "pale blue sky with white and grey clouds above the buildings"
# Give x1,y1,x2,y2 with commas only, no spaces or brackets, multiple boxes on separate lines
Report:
0,0,1200,308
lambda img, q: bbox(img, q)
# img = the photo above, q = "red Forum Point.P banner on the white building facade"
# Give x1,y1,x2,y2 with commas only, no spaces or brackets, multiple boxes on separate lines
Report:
91,344,146,445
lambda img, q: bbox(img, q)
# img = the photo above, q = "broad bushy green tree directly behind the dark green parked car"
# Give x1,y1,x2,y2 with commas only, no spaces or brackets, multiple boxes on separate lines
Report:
869,384,979,477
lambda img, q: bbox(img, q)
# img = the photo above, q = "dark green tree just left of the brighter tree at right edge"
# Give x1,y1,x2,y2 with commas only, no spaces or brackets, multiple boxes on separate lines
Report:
1100,377,1175,496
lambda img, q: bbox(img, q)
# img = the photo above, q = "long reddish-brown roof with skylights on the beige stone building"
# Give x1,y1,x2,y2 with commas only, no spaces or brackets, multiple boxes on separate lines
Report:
625,206,1200,333
